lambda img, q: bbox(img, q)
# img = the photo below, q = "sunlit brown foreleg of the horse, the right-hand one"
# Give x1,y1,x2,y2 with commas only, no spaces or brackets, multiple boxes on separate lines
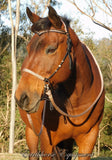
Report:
75,124,99,160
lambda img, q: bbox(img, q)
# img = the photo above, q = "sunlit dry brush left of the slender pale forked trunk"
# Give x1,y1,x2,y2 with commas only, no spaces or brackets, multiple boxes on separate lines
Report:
0,47,11,151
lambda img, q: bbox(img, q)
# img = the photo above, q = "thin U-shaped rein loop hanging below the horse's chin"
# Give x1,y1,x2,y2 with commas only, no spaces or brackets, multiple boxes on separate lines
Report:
27,100,47,136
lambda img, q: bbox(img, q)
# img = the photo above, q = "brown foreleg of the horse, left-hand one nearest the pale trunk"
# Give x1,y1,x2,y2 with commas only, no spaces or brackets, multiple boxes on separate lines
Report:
26,126,39,160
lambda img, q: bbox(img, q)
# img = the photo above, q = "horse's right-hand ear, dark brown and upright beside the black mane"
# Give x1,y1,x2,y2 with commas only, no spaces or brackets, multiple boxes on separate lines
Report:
48,6,62,29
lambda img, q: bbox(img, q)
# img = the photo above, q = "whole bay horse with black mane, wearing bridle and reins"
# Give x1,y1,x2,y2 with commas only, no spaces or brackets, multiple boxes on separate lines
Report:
15,6,105,160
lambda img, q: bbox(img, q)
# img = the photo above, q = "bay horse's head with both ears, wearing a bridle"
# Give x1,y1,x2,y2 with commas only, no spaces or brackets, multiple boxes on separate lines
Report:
15,6,76,113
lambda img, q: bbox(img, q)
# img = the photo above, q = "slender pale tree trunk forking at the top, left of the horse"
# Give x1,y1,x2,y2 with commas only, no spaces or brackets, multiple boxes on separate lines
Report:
8,0,20,153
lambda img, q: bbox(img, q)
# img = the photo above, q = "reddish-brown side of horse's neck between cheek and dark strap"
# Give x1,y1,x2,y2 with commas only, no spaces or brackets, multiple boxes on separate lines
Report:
65,29,93,96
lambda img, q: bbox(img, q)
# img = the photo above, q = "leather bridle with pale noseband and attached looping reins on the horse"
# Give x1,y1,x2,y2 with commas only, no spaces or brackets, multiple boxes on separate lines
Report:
23,21,103,136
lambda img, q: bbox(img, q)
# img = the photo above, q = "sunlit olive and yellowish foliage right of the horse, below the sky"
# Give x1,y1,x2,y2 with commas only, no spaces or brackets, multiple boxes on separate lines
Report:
83,33,112,157
